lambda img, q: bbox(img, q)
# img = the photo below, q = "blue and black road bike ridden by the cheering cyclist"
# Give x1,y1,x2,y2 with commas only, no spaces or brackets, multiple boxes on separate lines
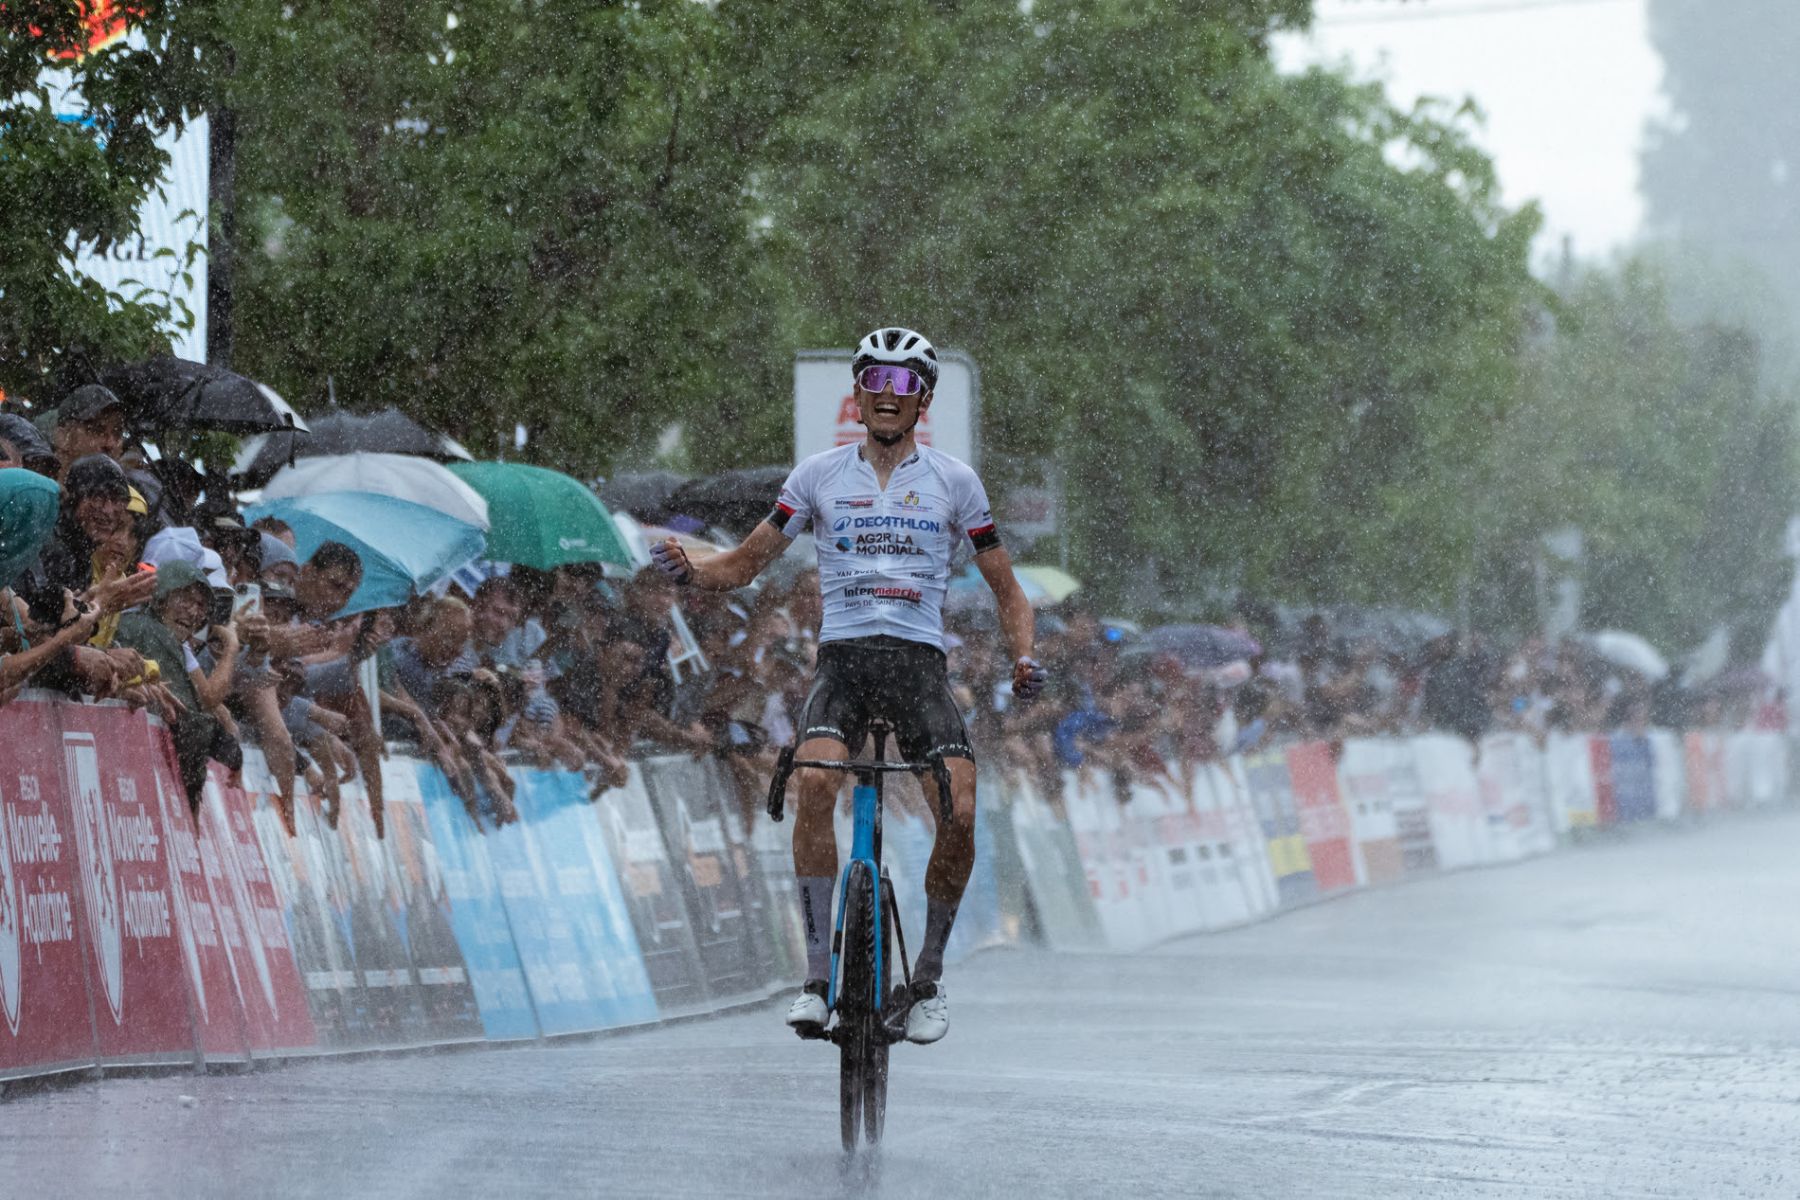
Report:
769,721,950,1153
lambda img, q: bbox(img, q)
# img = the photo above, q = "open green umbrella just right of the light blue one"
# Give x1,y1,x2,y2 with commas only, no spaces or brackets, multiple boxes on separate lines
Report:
448,462,634,570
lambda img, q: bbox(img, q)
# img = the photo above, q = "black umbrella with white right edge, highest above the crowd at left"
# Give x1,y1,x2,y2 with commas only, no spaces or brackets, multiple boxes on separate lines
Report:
101,354,308,439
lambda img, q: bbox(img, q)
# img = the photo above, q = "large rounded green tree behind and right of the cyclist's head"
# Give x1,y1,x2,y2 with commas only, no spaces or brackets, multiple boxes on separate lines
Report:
765,0,1535,599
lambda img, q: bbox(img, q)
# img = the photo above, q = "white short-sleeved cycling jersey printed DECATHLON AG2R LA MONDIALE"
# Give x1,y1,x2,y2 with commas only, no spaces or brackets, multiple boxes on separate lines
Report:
769,443,999,649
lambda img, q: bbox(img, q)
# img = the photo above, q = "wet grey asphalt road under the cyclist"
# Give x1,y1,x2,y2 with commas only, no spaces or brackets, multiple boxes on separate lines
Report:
0,815,1800,1200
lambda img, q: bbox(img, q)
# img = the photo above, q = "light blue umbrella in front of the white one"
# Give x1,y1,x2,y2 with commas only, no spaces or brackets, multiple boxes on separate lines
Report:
243,491,484,615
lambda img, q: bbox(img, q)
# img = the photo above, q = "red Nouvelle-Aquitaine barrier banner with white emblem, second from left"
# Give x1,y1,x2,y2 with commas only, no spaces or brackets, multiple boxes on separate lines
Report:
58,703,196,1063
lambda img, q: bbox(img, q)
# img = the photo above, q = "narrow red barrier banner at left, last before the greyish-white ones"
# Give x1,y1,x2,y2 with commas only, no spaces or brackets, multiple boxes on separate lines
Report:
200,763,319,1054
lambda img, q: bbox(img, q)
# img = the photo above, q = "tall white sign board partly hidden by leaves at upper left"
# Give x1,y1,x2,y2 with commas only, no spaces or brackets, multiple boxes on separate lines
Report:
41,43,211,362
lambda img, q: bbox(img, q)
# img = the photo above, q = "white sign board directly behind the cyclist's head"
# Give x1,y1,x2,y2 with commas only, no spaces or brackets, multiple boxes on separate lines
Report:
794,351,981,470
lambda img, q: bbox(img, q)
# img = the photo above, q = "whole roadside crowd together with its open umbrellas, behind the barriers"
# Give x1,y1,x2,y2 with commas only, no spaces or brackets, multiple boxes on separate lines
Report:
0,368,1787,845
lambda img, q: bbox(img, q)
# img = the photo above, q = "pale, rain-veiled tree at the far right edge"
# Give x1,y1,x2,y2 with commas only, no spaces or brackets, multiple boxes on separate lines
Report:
1480,257,1796,657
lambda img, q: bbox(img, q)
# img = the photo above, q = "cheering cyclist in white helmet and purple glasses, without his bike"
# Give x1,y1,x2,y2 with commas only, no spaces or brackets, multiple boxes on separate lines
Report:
652,327,1048,1043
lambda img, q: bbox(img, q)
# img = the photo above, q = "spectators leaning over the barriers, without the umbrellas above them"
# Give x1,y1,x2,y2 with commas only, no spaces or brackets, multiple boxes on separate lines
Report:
0,385,1786,845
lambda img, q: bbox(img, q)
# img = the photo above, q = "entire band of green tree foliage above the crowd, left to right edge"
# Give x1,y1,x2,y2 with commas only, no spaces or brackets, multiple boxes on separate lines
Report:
0,0,1793,658
